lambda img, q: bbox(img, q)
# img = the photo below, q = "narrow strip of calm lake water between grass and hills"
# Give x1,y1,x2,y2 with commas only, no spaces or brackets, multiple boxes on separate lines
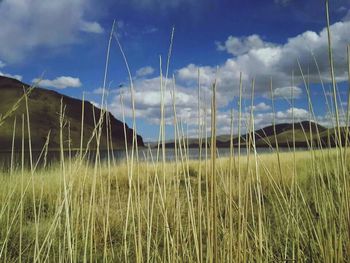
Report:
0,148,306,170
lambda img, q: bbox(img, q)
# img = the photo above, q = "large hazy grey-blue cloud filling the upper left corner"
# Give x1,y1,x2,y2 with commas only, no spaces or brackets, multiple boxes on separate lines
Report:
0,0,102,63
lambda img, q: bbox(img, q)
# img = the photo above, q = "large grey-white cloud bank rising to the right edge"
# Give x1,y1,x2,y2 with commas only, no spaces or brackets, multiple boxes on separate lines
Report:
177,21,350,102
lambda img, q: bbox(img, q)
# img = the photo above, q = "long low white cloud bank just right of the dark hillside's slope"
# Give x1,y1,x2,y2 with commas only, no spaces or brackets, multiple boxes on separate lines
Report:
108,73,310,137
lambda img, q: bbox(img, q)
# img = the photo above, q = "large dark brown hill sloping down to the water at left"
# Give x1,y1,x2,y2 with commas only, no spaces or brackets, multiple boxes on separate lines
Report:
0,76,144,151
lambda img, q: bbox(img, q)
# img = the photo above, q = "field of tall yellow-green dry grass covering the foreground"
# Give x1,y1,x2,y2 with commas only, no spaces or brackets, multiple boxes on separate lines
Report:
0,149,350,262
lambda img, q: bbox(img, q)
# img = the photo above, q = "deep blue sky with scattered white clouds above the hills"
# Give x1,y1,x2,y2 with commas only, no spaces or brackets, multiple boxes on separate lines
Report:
0,0,350,141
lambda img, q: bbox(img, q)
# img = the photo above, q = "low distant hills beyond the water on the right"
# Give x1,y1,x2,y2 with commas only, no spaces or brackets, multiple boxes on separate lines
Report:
160,121,350,148
